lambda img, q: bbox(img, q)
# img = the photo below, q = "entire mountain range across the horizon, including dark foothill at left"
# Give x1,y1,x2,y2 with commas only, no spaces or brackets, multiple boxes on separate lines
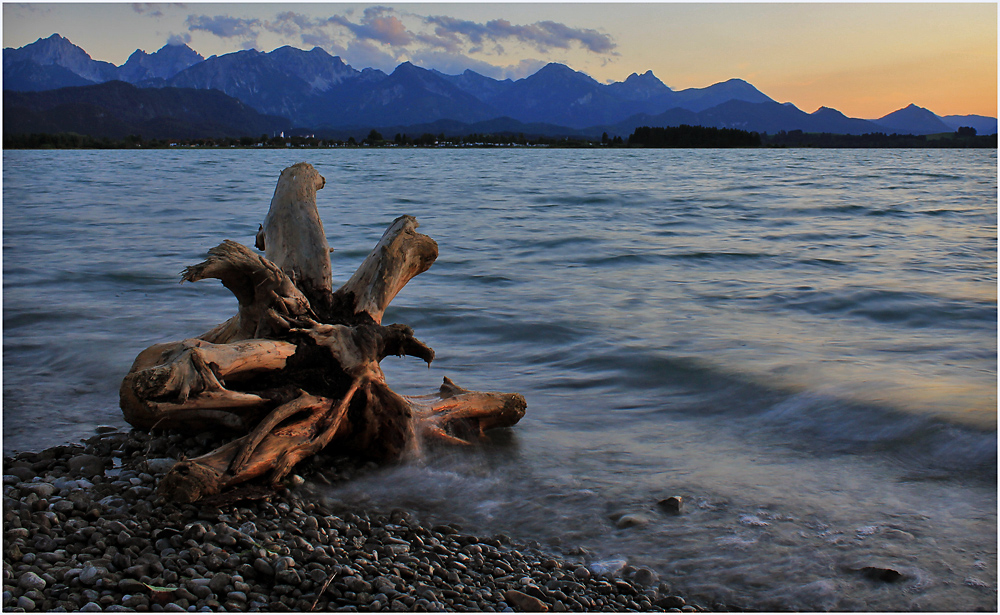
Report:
3,34,997,136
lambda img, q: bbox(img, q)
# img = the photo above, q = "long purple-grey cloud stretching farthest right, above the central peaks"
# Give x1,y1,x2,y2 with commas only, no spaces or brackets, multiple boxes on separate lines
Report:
425,15,617,55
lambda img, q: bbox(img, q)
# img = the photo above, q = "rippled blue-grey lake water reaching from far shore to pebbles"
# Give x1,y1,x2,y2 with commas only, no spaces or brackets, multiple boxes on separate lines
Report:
3,149,997,611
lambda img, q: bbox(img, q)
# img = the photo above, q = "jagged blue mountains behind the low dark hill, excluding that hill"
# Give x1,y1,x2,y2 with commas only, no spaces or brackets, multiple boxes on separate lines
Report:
3,33,996,134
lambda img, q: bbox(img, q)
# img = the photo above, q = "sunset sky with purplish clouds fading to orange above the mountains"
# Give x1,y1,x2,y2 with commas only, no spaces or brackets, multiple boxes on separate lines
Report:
3,2,997,119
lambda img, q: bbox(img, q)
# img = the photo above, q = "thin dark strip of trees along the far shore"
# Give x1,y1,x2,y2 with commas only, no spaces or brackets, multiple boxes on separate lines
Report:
3,125,997,149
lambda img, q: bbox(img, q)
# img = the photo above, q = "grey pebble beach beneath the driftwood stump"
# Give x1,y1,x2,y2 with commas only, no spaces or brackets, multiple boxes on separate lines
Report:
3,427,734,612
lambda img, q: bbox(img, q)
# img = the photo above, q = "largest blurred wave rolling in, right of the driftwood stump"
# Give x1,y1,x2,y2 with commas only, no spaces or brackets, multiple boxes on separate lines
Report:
532,348,997,479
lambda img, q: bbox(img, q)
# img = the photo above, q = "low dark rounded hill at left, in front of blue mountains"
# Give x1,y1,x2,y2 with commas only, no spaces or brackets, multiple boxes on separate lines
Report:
3,81,289,139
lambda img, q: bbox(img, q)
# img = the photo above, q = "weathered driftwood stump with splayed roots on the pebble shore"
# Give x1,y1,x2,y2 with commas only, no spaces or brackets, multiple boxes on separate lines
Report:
120,163,526,502
